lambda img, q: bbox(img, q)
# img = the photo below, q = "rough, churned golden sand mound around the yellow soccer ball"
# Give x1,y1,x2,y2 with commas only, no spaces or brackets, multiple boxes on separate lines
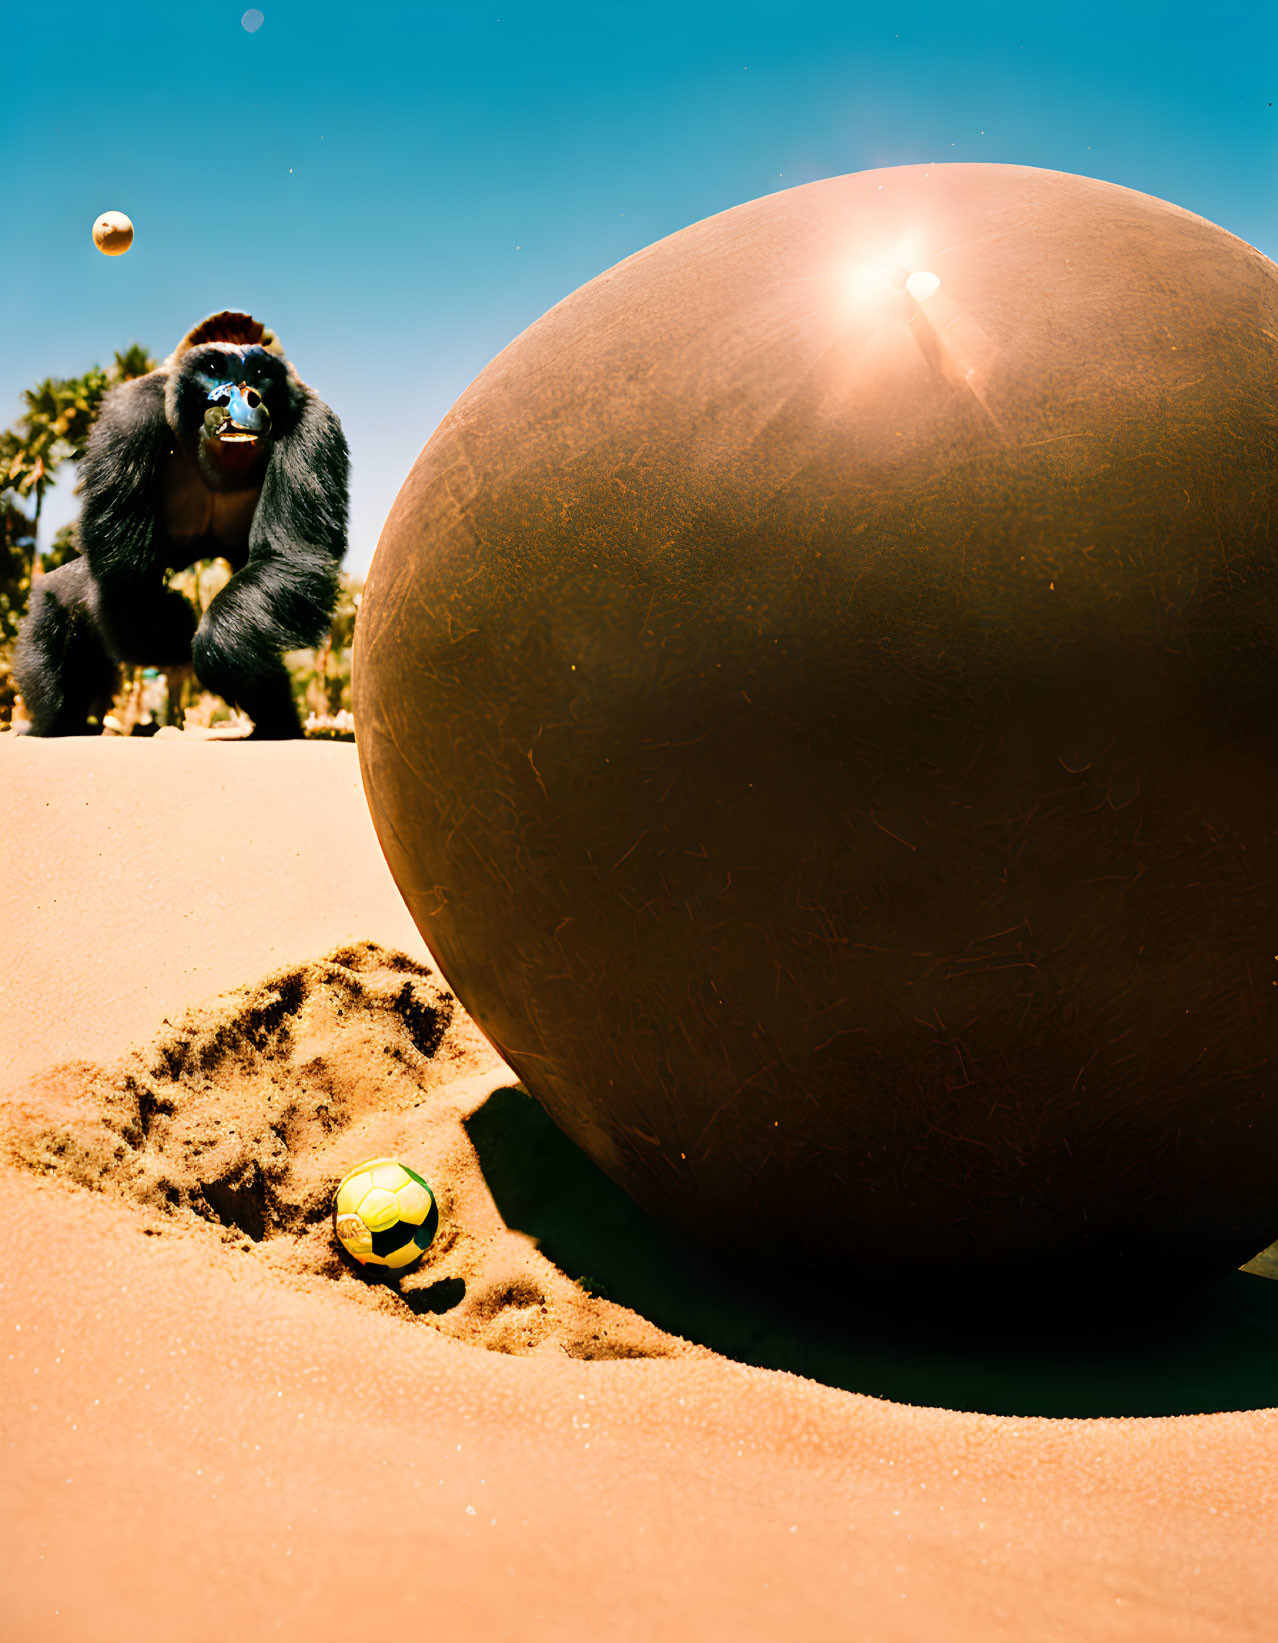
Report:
5,941,696,1359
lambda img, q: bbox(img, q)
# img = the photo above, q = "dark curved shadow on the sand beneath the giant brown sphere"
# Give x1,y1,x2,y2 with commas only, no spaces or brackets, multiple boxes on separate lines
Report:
467,1086,1278,1416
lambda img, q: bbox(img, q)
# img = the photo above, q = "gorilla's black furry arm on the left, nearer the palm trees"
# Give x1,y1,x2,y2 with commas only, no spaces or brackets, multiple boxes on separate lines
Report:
79,371,195,664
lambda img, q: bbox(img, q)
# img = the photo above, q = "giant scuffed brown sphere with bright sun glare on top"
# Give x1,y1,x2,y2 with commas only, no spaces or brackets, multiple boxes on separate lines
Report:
355,166,1278,1272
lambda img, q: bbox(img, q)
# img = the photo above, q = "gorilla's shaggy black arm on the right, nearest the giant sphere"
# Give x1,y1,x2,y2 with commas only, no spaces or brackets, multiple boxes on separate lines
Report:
192,389,350,738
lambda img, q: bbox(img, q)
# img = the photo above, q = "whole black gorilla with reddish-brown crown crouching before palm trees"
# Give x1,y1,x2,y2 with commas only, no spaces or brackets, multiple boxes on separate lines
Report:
13,311,350,739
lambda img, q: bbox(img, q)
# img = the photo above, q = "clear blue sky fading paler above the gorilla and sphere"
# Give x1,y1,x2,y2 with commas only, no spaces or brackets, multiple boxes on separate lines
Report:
0,0,1278,572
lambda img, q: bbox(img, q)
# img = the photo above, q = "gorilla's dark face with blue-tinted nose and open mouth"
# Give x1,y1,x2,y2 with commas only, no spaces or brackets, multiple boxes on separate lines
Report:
176,342,289,490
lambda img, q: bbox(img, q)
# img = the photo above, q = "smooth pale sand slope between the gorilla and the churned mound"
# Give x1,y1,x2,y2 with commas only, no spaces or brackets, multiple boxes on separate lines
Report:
0,734,427,1089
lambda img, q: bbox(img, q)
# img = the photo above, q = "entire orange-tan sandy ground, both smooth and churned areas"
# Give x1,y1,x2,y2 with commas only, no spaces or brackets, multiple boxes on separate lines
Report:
0,736,1278,1643
